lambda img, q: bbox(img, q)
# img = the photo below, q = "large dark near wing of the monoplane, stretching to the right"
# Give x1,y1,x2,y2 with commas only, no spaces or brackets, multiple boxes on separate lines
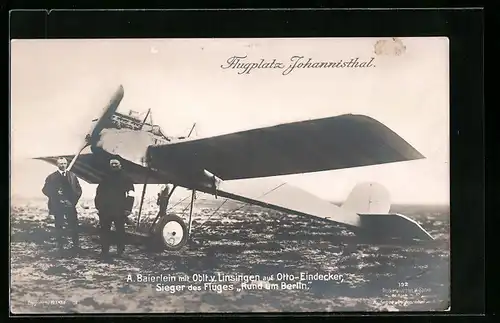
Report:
149,114,424,180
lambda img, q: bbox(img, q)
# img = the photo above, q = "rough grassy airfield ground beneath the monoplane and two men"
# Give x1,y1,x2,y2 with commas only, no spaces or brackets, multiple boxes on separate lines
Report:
10,200,449,313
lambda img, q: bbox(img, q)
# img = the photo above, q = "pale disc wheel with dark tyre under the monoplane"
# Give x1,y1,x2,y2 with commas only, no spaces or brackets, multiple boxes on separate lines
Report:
156,215,188,250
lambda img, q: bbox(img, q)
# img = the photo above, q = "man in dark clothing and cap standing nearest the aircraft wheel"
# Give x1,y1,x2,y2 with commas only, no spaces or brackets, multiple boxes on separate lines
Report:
94,159,134,257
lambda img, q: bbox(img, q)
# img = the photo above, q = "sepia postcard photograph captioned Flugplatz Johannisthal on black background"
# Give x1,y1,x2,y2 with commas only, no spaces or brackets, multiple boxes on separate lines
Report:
9,37,450,314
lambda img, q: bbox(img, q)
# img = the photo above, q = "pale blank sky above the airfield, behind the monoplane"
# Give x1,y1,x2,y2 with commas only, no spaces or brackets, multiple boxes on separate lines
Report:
11,38,449,203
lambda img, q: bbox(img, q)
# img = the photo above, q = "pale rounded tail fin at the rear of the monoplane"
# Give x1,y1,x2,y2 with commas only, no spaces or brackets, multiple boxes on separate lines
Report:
341,182,391,214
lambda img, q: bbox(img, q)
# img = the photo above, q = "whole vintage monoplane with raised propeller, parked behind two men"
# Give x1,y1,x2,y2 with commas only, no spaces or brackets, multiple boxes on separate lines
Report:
37,86,432,250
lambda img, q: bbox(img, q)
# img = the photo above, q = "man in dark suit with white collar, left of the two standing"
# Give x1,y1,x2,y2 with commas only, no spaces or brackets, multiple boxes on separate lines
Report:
42,158,82,251
